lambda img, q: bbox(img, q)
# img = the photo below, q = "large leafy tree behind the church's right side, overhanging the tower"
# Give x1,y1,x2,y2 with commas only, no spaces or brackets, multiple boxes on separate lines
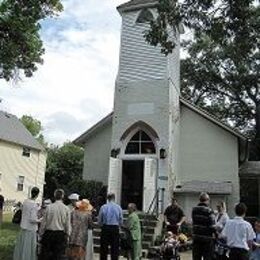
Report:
145,0,260,160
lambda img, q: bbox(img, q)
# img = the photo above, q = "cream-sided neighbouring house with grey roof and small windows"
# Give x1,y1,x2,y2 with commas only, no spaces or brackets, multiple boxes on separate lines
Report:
0,111,46,202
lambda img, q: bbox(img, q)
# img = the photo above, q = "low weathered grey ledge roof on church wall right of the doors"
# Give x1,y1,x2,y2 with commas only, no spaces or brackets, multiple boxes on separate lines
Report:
174,180,232,194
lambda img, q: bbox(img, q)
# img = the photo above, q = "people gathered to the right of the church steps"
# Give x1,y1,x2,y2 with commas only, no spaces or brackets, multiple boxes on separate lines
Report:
165,193,260,260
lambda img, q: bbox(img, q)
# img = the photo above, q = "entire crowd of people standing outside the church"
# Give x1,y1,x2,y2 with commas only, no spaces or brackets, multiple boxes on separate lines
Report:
0,187,260,260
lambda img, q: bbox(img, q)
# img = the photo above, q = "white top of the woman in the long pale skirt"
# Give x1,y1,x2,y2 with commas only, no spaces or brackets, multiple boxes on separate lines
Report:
20,199,39,232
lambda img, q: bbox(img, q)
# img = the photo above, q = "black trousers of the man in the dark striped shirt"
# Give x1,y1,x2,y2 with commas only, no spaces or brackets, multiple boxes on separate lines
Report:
192,240,214,260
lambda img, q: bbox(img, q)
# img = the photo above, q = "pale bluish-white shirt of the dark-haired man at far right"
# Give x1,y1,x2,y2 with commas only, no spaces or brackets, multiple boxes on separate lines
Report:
221,217,255,250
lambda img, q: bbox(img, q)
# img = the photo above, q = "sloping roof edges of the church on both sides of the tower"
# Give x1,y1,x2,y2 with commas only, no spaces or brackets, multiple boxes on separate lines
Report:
73,98,247,145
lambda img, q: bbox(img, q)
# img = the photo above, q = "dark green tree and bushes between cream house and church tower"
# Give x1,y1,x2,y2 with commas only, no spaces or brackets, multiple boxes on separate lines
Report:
44,142,103,200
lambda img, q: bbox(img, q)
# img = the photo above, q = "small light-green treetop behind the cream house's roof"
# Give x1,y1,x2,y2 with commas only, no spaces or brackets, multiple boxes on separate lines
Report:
20,115,46,145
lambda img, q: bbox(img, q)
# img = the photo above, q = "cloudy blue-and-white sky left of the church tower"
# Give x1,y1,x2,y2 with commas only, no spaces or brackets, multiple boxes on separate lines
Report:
0,0,127,145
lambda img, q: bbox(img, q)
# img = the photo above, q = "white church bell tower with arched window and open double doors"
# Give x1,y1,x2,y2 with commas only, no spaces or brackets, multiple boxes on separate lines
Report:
108,0,180,211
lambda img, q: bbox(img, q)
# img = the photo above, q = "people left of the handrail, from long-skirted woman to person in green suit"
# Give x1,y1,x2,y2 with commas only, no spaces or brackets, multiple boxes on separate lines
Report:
10,187,141,260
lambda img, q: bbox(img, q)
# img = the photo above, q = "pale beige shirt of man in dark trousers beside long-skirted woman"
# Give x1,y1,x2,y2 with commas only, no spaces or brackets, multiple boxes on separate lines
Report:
40,200,71,235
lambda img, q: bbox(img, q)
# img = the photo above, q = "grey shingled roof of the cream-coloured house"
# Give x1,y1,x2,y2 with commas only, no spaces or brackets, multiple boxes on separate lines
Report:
0,111,44,150
